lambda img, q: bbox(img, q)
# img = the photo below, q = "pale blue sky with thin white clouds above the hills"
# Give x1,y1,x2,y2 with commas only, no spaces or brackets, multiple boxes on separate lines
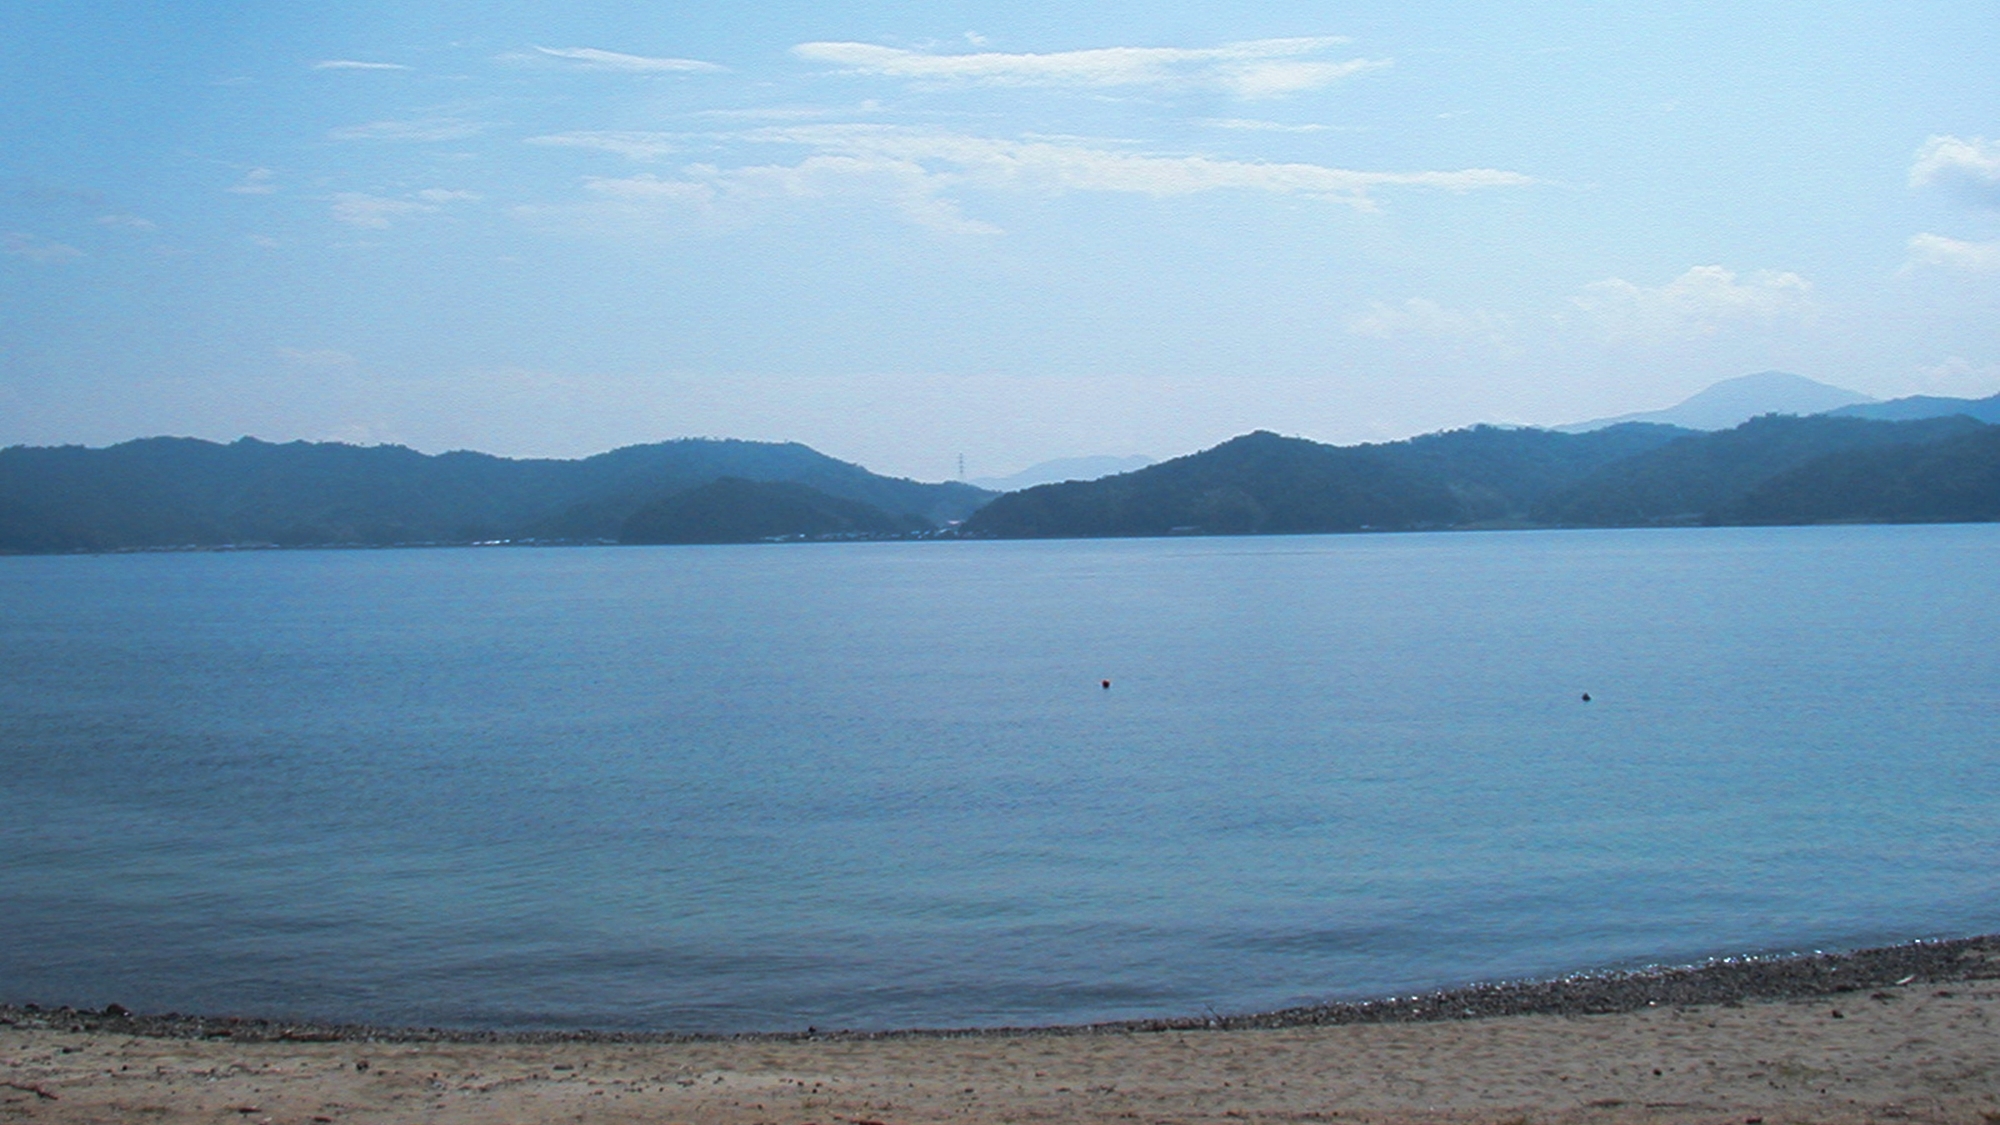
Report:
0,0,2000,480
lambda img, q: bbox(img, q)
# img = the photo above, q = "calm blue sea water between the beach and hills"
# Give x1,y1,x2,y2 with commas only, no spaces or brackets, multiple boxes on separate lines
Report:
0,524,2000,1031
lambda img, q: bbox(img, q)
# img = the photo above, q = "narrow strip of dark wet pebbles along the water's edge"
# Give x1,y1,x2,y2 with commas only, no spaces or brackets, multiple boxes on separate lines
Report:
0,933,2000,1045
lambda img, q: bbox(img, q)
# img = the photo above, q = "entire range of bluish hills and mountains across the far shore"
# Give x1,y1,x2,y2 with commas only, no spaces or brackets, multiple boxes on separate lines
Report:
0,372,2000,552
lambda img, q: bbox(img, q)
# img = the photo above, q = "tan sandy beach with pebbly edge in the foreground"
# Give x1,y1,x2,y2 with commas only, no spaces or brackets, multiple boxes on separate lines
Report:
0,939,2000,1125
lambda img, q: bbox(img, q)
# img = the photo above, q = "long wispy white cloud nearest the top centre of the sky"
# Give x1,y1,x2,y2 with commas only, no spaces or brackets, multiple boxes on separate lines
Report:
792,36,1390,98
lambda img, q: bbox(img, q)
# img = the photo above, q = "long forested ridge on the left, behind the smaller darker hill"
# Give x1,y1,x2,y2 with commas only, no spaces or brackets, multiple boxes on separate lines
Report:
0,430,992,550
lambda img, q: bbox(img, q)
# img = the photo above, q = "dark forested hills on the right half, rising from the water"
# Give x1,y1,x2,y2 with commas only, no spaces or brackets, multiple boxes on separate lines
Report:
964,414,2000,538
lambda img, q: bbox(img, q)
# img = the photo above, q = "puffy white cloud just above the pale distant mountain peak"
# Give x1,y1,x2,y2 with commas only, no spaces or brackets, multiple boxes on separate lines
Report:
1574,266,1814,342
